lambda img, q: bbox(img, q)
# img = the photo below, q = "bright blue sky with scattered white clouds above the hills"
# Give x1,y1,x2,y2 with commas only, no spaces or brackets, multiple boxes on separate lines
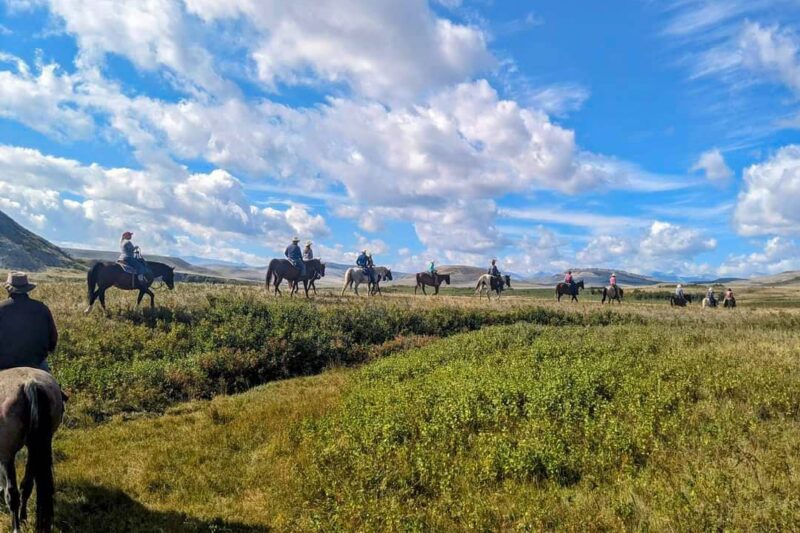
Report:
0,0,800,277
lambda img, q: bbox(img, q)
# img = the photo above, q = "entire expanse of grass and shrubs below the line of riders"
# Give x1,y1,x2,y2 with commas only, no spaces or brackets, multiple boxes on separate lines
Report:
9,283,800,531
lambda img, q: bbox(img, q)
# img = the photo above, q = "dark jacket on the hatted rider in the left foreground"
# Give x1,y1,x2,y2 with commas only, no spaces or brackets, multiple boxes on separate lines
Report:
0,294,58,370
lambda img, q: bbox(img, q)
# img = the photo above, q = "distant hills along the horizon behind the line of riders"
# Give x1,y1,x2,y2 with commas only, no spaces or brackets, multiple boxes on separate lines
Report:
0,211,800,287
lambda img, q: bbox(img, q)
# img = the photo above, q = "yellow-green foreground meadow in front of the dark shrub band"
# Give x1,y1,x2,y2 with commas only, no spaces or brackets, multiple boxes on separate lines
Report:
56,302,800,531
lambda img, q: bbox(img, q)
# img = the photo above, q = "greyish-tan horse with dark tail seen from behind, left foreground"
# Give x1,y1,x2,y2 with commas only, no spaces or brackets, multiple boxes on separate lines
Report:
0,368,64,533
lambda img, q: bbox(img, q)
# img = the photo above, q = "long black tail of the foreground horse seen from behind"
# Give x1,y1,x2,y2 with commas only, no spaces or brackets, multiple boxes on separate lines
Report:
24,381,55,531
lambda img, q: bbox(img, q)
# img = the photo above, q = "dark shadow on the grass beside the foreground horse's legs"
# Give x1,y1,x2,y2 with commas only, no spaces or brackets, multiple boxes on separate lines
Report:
55,483,270,533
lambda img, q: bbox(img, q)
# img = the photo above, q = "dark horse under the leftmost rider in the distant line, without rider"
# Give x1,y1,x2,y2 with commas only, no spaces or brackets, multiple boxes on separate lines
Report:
84,261,175,315
